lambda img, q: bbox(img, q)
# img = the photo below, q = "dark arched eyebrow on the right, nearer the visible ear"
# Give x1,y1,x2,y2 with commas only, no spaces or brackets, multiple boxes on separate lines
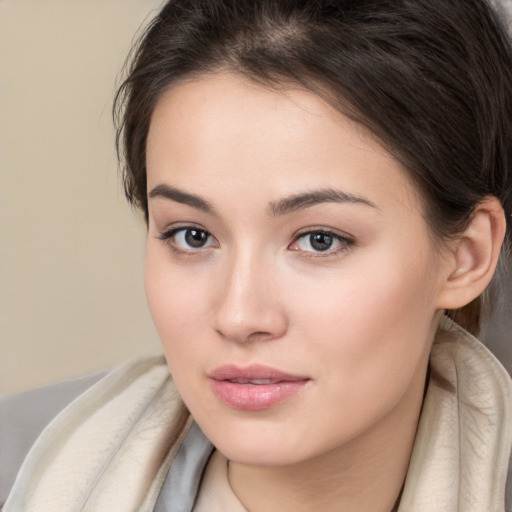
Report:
269,188,378,217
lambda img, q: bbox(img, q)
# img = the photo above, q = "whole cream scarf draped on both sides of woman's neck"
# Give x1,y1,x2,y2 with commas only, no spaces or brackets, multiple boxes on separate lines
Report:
4,319,512,512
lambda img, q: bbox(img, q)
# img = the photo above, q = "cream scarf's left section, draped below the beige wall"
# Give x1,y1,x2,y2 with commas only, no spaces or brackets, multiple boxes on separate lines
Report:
5,355,192,512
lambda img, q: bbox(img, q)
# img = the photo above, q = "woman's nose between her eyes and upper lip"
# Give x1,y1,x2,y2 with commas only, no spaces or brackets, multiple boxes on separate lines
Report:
215,252,288,343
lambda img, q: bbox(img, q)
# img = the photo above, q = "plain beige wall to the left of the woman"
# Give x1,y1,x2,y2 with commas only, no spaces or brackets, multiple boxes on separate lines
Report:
0,0,161,393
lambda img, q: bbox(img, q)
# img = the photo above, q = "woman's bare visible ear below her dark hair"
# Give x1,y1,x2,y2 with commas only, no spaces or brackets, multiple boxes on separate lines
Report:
438,196,506,309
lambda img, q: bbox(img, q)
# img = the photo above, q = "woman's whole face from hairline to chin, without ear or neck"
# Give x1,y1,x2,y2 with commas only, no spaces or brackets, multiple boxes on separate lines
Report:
145,74,452,465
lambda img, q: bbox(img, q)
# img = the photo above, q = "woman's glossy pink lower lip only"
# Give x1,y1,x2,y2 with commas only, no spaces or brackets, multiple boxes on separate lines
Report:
211,379,308,411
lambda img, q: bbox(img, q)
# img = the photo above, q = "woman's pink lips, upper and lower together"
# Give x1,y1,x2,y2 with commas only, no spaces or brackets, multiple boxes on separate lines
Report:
208,365,310,411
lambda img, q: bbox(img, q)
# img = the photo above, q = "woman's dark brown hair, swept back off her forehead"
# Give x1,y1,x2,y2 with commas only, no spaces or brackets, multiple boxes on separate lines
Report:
114,0,512,332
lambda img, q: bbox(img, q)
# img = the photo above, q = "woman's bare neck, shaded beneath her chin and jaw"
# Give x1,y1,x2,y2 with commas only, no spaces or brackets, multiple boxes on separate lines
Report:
228,360,426,512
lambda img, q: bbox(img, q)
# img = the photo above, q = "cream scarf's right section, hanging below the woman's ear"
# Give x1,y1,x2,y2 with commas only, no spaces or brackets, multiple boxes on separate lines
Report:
398,318,512,512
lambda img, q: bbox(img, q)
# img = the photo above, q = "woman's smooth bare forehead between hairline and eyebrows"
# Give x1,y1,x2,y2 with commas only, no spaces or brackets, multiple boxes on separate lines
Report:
147,73,418,212
